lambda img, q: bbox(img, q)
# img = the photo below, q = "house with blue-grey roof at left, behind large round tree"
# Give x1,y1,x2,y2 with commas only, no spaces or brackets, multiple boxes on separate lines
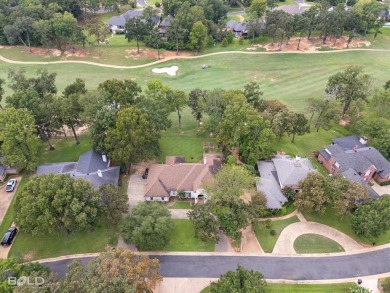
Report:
36,150,120,188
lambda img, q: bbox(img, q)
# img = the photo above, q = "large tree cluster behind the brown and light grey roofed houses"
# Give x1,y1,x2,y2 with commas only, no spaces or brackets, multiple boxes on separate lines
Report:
188,82,309,165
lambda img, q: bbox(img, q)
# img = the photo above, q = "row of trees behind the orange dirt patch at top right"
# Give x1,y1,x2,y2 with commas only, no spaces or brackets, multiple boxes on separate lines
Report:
266,1,385,50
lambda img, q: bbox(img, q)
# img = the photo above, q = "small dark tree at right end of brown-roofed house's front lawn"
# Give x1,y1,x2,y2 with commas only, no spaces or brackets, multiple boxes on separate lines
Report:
187,203,219,241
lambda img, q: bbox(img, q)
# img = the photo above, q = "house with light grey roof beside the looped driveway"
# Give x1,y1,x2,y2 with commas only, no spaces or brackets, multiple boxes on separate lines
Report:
256,155,317,209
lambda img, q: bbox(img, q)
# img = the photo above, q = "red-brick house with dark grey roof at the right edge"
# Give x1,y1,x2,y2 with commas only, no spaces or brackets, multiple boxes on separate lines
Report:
318,135,390,184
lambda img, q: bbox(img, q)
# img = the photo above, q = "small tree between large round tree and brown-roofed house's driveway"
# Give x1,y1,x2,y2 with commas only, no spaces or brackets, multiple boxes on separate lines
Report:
99,184,128,224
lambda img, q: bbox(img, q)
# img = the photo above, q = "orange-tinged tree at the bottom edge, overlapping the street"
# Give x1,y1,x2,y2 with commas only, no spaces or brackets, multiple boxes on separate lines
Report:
53,247,162,293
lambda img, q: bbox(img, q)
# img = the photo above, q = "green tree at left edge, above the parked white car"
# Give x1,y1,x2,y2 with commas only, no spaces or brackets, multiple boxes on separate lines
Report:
0,108,41,171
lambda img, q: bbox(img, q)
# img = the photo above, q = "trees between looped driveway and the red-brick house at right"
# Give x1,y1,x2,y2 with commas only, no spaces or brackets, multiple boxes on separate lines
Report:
291,173,390,237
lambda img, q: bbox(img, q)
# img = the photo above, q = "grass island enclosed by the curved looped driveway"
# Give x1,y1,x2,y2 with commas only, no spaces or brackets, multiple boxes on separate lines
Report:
294,234,345,254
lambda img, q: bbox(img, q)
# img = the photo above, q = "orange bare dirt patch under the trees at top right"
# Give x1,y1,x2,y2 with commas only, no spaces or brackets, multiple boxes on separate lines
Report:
264,37,371,52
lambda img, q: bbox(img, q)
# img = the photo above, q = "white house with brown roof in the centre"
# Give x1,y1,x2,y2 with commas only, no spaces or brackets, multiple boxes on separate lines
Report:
145,154,221,202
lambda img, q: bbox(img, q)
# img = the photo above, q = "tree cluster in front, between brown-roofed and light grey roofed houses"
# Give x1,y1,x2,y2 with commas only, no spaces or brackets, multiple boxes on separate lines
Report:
188,165,267,241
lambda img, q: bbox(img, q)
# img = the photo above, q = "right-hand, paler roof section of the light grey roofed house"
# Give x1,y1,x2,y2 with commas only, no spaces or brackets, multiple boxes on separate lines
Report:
272,155,317,186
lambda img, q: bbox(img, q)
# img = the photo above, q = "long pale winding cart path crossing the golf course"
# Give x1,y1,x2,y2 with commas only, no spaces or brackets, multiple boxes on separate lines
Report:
0,49,390,69
